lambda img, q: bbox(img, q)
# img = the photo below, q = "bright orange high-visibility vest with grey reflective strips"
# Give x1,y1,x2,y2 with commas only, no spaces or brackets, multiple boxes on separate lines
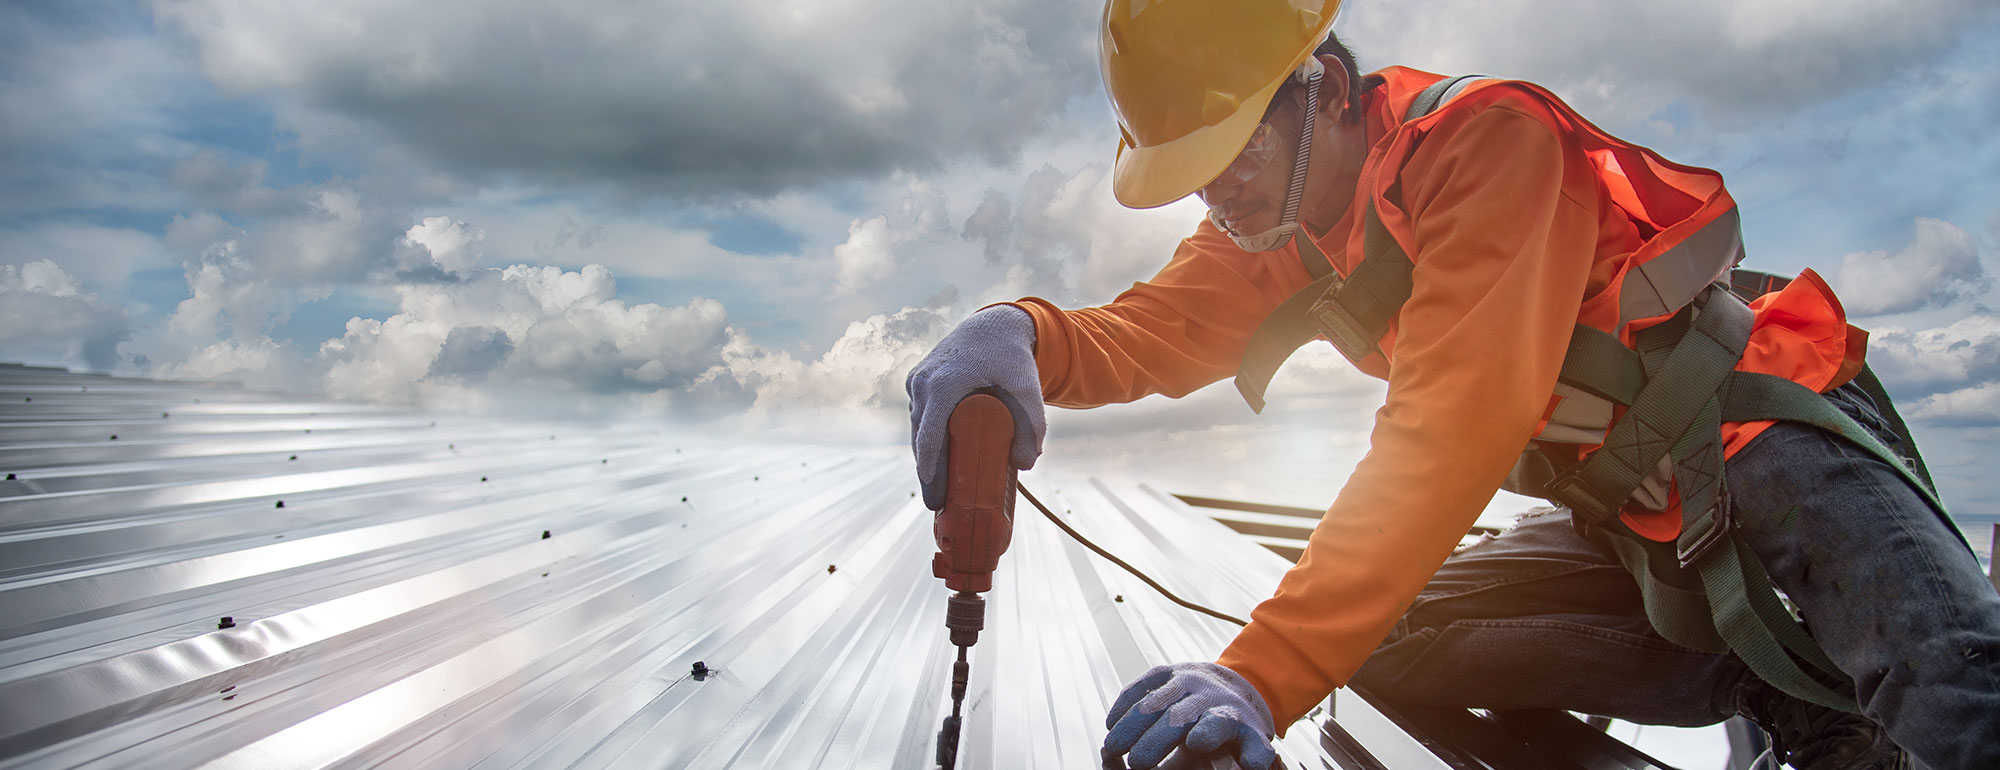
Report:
1236,68,1866,542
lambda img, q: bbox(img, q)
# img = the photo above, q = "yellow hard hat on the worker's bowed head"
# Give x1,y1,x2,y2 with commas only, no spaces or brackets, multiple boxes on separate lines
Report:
1098,0,1340,208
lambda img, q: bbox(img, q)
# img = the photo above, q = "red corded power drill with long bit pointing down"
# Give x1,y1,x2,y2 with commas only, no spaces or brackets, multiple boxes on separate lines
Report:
930,394,1014,770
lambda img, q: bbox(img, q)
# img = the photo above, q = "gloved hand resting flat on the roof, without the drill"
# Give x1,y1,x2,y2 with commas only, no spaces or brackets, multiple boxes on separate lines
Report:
1104,662,1278,770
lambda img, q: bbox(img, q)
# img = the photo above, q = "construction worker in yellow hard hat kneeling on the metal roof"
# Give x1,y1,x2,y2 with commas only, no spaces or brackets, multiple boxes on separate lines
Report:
908,0,2000,770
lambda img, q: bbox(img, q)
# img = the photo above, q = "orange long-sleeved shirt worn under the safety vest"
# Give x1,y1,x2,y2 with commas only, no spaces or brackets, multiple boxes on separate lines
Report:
1018,75,1846,730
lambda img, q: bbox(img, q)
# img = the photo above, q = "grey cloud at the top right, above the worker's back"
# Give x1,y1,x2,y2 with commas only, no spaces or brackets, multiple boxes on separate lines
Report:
1340,0,2000,128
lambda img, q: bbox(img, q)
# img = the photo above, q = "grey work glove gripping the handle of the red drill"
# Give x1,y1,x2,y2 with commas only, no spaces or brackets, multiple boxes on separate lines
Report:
904,304,1048,510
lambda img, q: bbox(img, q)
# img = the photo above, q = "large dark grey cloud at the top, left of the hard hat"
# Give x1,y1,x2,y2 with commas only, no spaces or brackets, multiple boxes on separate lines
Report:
154,0,1096,196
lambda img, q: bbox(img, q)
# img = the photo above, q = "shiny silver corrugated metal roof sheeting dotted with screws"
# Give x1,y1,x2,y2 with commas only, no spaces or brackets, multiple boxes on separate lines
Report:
0,366,1472,768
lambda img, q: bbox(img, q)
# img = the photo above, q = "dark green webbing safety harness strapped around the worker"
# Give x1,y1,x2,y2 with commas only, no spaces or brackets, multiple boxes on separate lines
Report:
1236,76,1970,712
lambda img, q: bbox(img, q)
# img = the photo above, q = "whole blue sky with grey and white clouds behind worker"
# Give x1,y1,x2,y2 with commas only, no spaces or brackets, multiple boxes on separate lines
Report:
0,0,2000,514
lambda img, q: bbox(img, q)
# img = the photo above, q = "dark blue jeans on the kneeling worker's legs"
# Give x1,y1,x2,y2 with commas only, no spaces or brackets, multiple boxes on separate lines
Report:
1354,384,2000,770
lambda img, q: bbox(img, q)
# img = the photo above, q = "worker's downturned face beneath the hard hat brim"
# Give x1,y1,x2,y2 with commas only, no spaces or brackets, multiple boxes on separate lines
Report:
1196,88,1304,236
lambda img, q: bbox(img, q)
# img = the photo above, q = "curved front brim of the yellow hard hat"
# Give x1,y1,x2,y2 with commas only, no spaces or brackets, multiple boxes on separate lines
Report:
1112,76,1290,208
